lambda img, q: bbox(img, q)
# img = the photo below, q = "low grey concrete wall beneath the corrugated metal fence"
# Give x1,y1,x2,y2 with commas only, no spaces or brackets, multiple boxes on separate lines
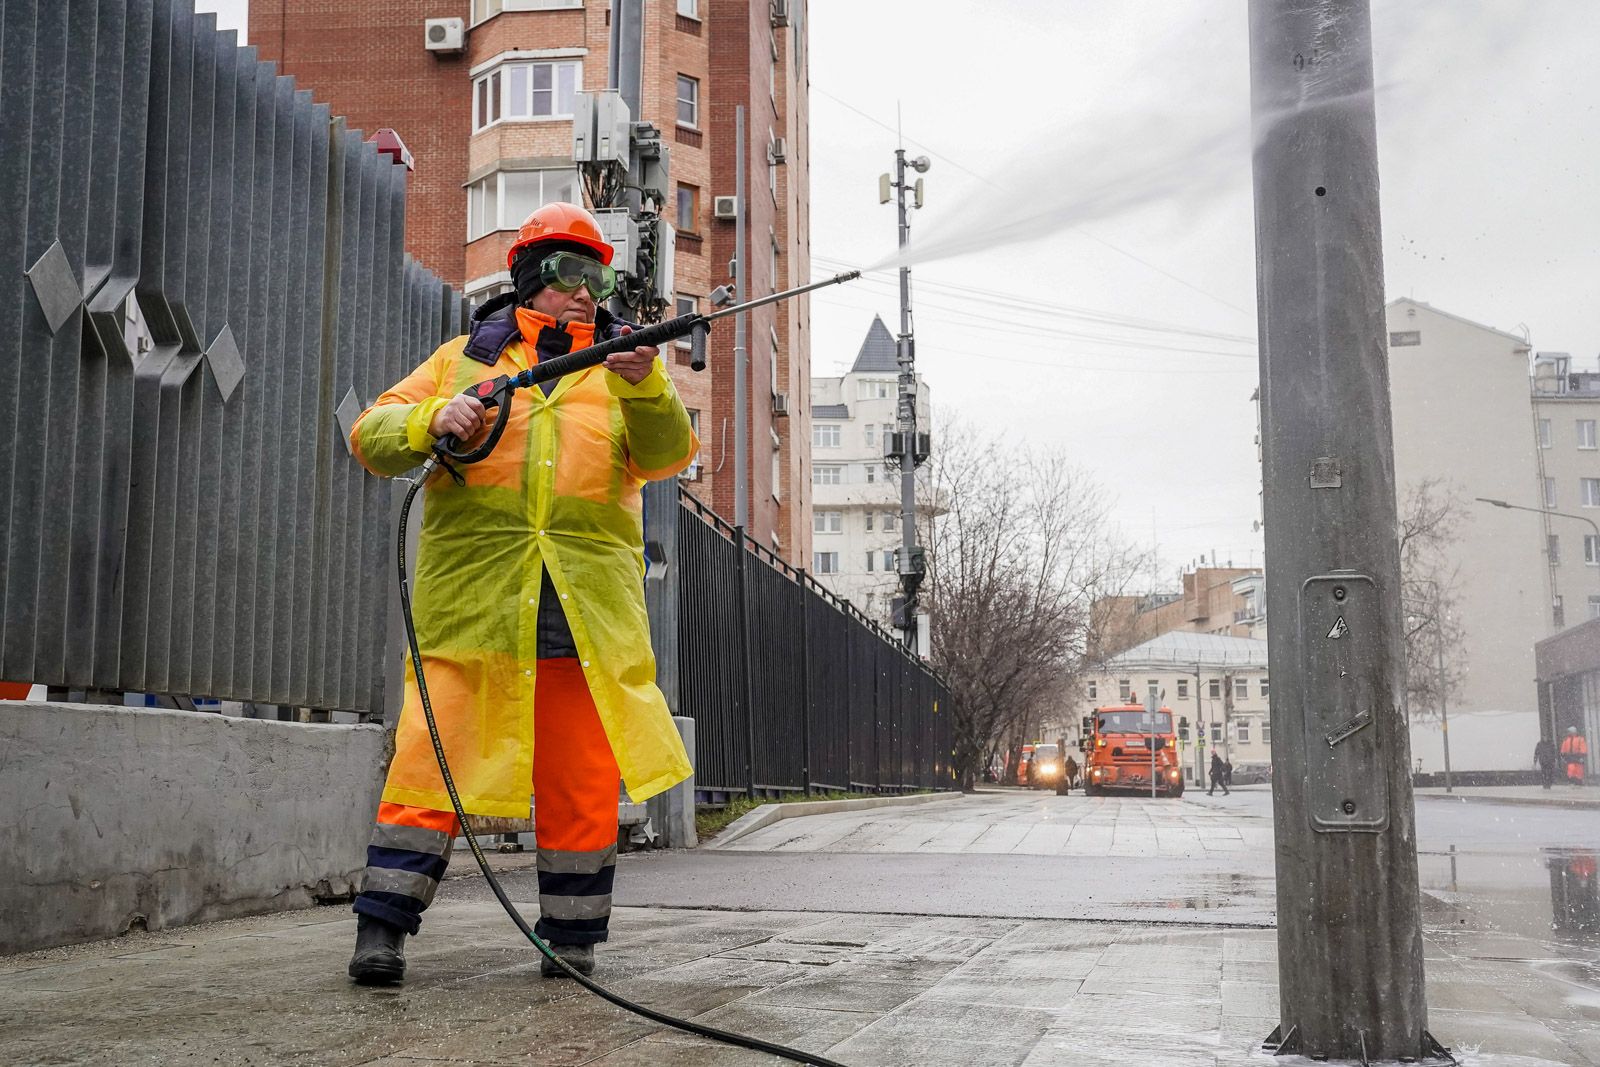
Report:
0,702,387,953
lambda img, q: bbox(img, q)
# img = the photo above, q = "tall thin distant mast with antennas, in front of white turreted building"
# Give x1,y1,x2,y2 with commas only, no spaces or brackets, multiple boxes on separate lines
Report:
885,149,928,649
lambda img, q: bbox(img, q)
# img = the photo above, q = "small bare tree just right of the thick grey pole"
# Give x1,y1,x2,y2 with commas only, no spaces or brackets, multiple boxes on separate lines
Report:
1400,477,1467,718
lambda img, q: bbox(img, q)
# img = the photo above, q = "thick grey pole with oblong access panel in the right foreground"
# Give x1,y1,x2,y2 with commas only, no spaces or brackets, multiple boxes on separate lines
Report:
1250,0,1443,1062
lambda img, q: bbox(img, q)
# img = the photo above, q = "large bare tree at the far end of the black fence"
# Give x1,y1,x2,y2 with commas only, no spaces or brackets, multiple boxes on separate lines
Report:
920,426,1142,789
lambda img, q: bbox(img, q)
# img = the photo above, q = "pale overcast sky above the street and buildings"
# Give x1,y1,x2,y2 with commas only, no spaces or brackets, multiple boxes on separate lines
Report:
198,0,1600,585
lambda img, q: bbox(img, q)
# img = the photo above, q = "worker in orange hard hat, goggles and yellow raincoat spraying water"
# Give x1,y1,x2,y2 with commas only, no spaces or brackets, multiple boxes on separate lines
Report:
349,203,699,984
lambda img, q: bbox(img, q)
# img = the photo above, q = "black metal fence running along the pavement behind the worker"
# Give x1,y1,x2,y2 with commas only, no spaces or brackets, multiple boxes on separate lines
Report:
677,493,955,795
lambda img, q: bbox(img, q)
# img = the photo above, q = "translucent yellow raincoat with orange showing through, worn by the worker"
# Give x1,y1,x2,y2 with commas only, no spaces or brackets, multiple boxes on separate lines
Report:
350,309,699,817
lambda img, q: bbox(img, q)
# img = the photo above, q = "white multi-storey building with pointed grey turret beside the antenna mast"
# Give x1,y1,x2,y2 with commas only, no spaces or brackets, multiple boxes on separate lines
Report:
811,318,931,627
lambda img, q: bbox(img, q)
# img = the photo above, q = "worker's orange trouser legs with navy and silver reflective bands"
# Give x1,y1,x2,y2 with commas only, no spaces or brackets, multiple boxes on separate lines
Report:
355,659,619,944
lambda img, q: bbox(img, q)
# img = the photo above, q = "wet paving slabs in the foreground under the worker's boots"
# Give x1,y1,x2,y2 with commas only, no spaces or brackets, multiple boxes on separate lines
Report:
0,904,1600,1067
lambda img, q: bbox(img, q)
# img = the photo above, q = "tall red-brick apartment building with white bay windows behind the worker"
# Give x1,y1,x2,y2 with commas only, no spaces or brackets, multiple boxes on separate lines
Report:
259,0,811,566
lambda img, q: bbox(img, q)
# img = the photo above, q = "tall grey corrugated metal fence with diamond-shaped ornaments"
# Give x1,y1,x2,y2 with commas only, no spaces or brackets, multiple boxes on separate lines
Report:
0,0,462,713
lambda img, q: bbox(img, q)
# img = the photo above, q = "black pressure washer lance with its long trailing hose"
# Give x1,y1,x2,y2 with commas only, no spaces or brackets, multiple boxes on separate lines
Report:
397,270,861,1067
